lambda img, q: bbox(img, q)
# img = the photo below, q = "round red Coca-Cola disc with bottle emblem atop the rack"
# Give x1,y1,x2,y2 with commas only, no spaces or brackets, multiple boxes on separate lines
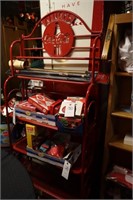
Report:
43,21,74,57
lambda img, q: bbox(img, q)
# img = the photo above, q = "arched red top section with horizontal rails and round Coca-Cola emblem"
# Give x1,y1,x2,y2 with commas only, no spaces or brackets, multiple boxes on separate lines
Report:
10,10,102,77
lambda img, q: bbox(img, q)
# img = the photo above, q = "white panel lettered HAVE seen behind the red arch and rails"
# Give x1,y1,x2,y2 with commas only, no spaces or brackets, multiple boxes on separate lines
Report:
40,0,102,71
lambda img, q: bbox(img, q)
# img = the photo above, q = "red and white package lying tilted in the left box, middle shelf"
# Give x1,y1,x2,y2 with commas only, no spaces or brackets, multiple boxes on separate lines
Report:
28,93,55,114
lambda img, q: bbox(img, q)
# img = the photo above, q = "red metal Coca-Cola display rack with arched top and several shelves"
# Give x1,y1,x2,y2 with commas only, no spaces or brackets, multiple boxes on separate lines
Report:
4,10,102,199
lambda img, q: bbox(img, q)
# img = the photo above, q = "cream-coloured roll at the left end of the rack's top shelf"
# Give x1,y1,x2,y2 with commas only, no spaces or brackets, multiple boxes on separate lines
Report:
8,60,29,69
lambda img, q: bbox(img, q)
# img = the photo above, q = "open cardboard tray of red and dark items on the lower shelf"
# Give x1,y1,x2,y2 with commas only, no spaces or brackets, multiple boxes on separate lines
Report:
26,132,81,170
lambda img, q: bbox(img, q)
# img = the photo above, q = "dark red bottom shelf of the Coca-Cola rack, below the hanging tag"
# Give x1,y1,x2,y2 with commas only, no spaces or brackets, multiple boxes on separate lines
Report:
24,158,81,199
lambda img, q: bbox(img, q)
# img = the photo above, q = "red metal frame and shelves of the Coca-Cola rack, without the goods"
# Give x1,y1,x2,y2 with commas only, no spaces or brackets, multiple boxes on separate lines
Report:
4,10,102,199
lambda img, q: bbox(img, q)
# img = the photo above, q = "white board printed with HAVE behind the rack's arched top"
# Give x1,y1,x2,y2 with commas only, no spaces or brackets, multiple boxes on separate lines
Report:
40,0,94,68
